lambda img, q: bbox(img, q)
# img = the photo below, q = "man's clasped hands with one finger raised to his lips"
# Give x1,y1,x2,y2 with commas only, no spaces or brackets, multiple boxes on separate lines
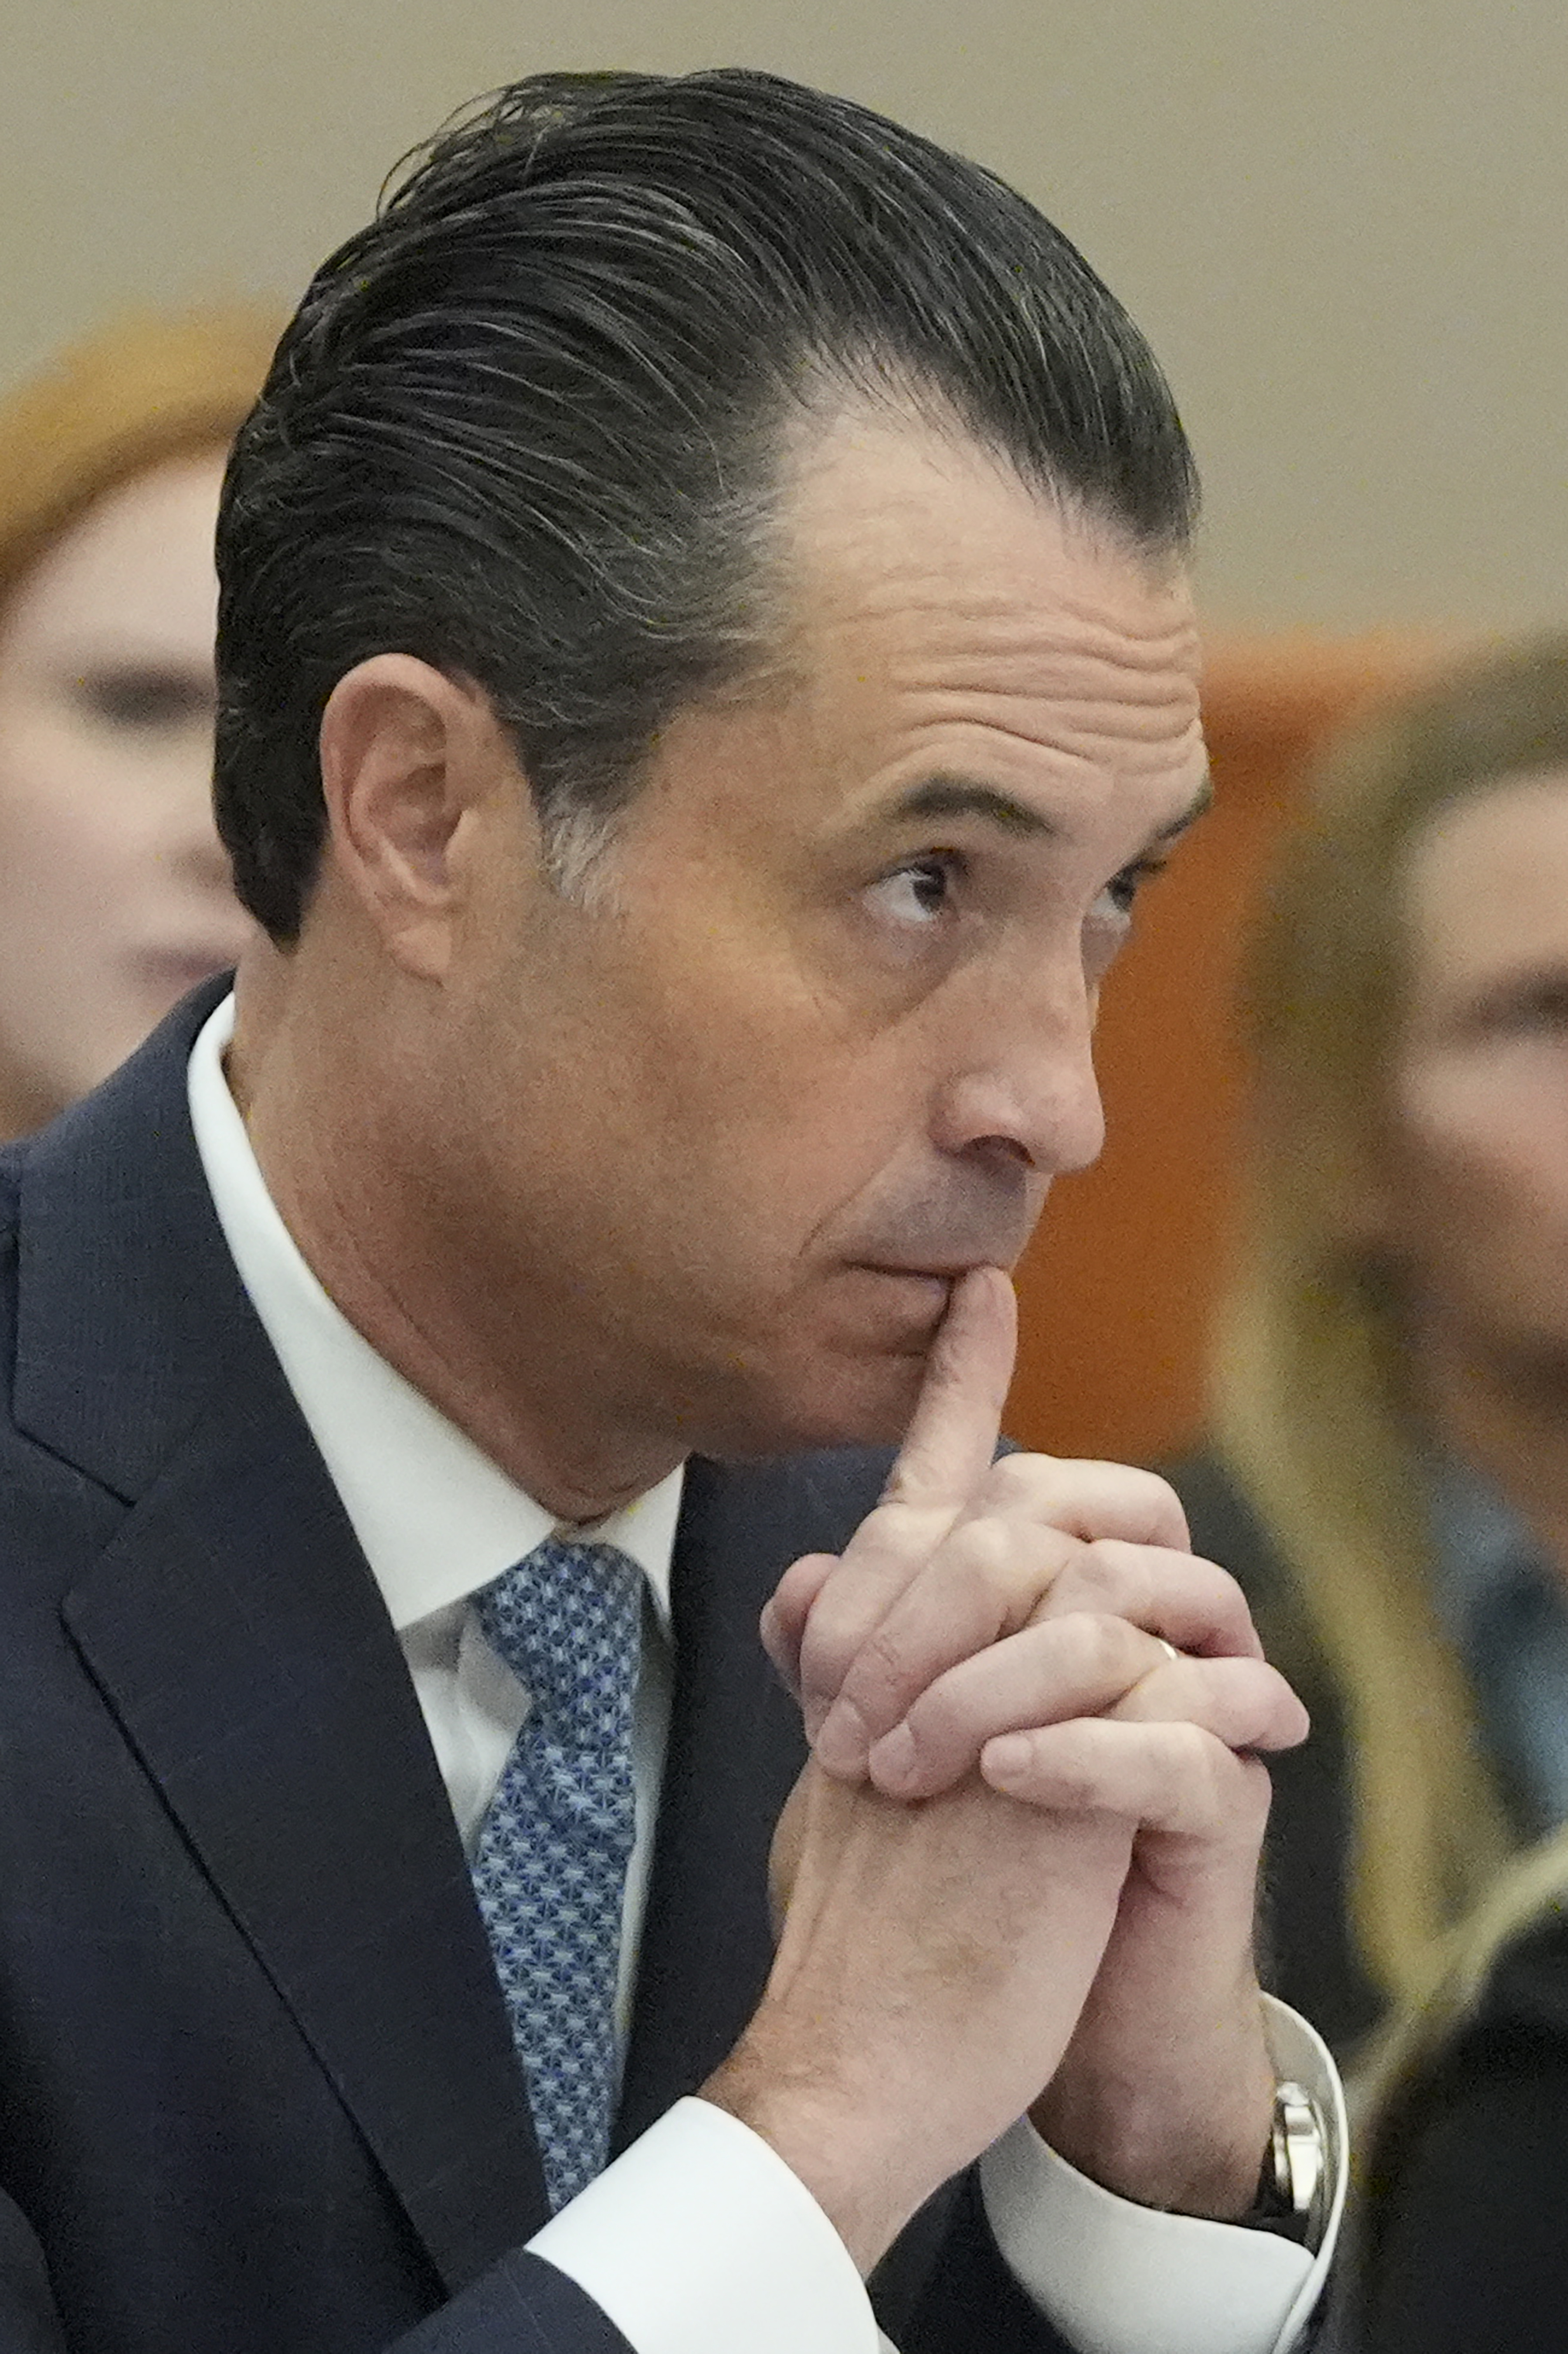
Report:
713,1269,1307,2262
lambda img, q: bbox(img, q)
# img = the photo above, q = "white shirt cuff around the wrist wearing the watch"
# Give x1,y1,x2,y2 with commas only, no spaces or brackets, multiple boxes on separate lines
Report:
979,1996,1347,2354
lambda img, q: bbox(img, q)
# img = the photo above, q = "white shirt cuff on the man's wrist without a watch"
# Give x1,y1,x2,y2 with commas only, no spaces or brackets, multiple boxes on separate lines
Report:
530,2100,888,2354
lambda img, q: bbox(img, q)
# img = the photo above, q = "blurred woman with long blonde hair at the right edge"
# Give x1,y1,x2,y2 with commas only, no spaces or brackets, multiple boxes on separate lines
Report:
1175,640,1568,2046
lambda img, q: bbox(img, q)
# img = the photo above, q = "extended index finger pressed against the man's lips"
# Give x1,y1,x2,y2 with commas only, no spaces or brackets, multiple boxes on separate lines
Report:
798,1266,1017,1740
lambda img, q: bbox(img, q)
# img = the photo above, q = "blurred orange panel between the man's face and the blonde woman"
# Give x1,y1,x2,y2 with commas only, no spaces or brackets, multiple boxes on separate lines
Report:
1008,633,1455,1462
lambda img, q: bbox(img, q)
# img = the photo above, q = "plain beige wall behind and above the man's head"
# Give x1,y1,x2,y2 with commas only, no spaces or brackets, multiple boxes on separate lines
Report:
0,0,1568,626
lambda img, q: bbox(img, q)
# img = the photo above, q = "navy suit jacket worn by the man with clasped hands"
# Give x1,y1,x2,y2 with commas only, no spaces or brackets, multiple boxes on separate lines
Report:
0,989,1059,2354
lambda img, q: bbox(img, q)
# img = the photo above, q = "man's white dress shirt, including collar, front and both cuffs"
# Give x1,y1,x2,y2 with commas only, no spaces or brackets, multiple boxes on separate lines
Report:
180,998,1344,2354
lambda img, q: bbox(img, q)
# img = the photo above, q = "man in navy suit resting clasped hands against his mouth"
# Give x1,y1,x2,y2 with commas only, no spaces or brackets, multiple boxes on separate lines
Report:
0,75,1337,2354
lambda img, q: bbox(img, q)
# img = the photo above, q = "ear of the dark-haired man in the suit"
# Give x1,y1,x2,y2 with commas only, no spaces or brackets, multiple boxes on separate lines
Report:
320,654,516,979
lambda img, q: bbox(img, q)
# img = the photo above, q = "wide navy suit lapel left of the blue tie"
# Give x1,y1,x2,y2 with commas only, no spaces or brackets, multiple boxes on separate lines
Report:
17,1007,546,2288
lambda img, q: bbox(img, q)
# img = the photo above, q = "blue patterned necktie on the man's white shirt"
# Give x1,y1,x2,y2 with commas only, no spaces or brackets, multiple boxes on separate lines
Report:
473,1537,643,2208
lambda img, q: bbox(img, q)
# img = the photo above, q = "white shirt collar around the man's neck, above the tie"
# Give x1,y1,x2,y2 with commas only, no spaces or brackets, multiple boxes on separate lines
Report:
188,998,683,1634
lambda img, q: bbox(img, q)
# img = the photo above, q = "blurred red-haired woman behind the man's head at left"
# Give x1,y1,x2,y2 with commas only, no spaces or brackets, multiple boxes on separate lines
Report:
0,311,278,1140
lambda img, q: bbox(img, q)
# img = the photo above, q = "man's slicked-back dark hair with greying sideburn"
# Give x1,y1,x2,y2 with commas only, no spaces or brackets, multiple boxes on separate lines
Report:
217,71,1196,942
